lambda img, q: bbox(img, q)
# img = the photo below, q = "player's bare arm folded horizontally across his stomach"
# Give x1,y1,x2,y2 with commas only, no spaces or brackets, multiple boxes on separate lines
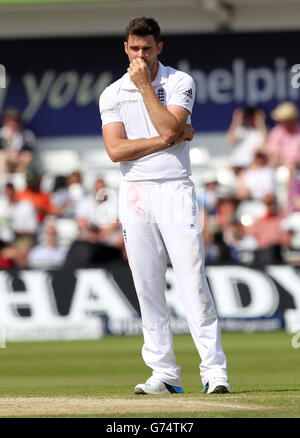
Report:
102,122,194,163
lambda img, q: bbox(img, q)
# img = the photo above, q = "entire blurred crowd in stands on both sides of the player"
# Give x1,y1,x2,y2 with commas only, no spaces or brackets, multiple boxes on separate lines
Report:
0,102,300,269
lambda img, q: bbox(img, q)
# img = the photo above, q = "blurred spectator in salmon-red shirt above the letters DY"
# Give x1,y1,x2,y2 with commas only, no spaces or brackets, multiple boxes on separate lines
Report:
246,194,292,264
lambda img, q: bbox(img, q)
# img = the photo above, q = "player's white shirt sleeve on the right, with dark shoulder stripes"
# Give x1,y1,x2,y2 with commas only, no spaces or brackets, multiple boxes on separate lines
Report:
167,72,196,113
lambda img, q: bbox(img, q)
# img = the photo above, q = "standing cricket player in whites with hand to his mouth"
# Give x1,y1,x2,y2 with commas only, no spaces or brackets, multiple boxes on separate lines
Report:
100,17,231,395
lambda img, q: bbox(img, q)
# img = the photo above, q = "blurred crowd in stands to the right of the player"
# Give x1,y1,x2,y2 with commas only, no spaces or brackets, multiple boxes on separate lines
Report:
202,102,300,265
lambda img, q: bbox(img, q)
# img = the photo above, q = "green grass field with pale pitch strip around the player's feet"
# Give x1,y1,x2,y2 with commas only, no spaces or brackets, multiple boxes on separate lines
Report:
0,331,300,418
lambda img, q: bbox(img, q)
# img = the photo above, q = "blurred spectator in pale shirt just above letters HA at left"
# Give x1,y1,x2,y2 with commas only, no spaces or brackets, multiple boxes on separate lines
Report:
27,220,67,269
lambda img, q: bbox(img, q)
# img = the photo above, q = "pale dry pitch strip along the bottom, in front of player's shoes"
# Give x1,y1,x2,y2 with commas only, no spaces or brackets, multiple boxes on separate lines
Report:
0,396,265,417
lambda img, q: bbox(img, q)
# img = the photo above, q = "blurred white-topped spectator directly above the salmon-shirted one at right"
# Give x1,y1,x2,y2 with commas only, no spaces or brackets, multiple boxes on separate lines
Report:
236,150,276,200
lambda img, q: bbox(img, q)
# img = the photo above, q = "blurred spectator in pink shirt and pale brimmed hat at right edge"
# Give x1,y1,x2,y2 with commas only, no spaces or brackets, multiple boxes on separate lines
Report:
267,102,300,171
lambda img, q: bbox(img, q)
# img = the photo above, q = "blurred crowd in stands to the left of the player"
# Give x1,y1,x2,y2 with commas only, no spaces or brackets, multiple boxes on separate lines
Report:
0,108,126,269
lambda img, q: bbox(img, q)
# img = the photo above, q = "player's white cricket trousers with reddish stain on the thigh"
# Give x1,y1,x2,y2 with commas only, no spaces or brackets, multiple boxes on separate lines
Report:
119,177,227,386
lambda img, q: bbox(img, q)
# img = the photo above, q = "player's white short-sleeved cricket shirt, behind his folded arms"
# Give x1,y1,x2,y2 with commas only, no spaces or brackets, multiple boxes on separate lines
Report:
99,62,195,181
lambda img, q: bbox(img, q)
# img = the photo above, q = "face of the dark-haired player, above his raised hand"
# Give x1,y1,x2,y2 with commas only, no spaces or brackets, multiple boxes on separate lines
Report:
124,35,163,72
